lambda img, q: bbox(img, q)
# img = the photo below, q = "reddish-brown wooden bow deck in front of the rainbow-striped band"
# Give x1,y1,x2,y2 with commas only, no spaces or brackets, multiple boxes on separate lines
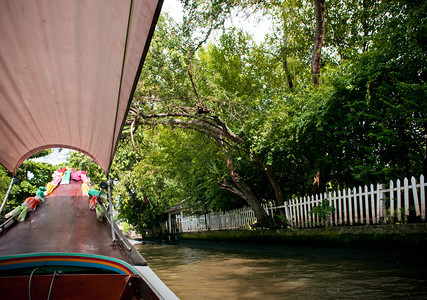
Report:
0,181,132,263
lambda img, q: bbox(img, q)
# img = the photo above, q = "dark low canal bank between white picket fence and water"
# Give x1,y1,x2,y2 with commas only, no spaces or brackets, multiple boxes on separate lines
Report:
178,223,427,250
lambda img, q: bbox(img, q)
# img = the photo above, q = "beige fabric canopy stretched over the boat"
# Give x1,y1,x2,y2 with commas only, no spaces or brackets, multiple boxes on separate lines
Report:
0,0,163,173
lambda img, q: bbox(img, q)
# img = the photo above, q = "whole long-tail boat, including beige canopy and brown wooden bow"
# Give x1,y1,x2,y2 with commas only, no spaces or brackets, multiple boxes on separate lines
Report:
0,0,176,300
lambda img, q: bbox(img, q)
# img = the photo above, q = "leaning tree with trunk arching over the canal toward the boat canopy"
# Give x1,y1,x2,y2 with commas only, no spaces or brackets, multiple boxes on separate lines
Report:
127,15,288,224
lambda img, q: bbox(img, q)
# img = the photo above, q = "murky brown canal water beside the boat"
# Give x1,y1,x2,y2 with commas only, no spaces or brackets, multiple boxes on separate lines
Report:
136,241,427,300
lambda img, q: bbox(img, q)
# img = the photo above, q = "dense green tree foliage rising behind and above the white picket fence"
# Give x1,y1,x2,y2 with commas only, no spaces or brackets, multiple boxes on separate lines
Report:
102,0,427,232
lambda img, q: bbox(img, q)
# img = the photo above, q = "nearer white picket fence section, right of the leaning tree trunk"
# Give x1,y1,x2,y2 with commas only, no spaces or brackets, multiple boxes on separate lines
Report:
276,175,427,228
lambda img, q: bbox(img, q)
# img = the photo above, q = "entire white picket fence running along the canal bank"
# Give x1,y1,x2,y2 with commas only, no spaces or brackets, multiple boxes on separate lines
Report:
176,175,427,232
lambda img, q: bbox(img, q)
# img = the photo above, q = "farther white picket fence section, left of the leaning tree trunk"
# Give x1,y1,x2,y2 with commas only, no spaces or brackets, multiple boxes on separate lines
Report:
176,205,268,232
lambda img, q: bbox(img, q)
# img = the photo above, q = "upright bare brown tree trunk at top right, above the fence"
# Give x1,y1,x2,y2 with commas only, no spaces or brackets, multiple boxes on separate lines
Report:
311,0,325,86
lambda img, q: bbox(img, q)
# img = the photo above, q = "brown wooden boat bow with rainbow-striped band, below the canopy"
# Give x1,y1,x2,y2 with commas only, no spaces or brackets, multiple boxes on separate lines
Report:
0,181,177,299
